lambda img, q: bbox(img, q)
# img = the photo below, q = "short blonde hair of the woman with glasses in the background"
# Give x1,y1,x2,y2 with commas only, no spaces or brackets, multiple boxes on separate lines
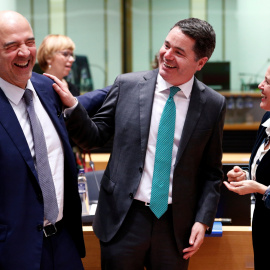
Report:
37,35,75,71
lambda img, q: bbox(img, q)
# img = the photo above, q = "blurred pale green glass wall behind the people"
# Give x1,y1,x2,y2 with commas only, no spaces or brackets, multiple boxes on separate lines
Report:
0,0,270,92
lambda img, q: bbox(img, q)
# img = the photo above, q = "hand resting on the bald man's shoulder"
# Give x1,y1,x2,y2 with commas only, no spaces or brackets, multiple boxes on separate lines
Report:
43,73,77,108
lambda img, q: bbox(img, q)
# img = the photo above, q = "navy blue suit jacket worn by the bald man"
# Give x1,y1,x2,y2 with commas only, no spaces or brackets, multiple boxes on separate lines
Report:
0,73,85,270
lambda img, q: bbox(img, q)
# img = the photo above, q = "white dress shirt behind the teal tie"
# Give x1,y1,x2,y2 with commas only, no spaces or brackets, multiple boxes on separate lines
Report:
135,74,194,204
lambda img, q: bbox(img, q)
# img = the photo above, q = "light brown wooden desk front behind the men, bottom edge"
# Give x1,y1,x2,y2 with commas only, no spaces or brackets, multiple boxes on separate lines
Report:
82,226,254,270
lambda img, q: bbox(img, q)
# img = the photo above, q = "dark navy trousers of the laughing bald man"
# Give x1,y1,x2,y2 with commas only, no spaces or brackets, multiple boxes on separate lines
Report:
40,223,84,270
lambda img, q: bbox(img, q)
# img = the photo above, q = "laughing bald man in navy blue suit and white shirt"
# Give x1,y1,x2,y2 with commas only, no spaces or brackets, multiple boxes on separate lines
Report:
0,11,85,270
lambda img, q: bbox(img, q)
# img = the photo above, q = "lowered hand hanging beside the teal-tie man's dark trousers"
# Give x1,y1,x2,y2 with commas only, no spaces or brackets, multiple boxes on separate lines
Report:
183,222,207,260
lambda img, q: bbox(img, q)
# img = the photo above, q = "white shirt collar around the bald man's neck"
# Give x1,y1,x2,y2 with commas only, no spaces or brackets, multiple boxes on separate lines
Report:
0,78,35,105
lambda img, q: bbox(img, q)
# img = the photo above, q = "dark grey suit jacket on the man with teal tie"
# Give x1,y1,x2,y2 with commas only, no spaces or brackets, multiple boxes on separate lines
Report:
66,70,226,252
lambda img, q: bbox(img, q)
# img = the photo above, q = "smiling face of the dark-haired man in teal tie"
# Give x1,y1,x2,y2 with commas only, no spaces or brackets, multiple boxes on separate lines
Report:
159,27,208,85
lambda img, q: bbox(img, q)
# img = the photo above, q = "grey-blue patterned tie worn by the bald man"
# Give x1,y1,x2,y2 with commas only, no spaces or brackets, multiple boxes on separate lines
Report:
24,89,58,224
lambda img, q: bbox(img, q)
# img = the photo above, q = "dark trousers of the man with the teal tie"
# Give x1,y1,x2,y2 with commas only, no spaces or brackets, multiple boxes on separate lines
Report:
100,200,189,270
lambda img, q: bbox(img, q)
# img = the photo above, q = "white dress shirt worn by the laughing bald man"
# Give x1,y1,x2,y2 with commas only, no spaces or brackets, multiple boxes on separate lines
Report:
0,78,64,224
